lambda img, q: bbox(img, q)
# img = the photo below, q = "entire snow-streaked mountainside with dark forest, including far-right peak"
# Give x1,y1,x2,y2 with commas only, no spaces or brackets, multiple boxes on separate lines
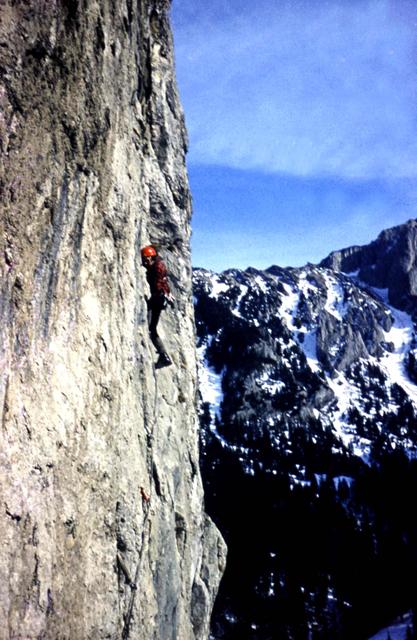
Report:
194,221,417,640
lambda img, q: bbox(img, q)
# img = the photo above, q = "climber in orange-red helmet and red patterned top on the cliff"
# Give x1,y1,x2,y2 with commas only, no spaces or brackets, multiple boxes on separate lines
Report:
141,245,173,369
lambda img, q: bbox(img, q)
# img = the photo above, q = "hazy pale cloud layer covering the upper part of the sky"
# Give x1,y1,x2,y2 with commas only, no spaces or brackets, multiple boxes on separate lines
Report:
174,0,417,178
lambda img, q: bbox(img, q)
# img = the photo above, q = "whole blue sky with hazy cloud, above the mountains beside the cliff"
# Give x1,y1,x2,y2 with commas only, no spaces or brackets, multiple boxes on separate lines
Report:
172,0,417,270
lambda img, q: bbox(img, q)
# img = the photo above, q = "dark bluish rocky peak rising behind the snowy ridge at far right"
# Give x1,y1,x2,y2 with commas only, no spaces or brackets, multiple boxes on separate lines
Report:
320,220,417,313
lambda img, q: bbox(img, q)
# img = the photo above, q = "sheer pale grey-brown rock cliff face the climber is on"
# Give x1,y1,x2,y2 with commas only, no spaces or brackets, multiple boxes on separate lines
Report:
0,0,225,640
